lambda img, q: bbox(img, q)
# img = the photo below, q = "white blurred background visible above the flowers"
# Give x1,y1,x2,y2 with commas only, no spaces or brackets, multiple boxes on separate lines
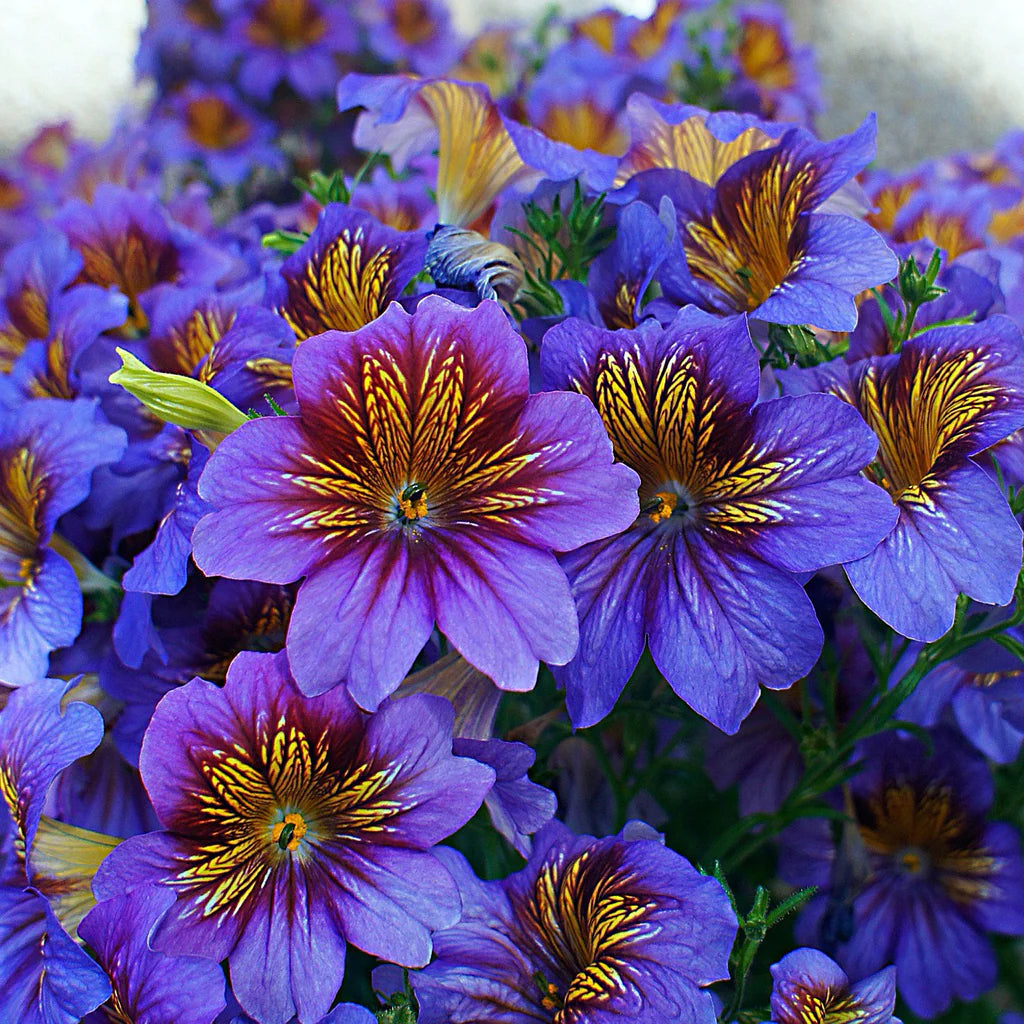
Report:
0,0,1024,167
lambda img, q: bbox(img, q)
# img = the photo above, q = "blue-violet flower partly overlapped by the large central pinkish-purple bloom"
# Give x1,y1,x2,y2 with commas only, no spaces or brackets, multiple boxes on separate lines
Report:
541,309,895,732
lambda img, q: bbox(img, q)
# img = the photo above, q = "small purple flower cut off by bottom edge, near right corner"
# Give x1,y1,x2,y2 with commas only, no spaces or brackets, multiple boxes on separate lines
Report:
766,949,900,1024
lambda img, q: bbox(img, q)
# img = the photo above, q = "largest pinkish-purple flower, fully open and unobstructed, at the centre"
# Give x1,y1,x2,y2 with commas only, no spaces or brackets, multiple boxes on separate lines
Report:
193,296,637,708
